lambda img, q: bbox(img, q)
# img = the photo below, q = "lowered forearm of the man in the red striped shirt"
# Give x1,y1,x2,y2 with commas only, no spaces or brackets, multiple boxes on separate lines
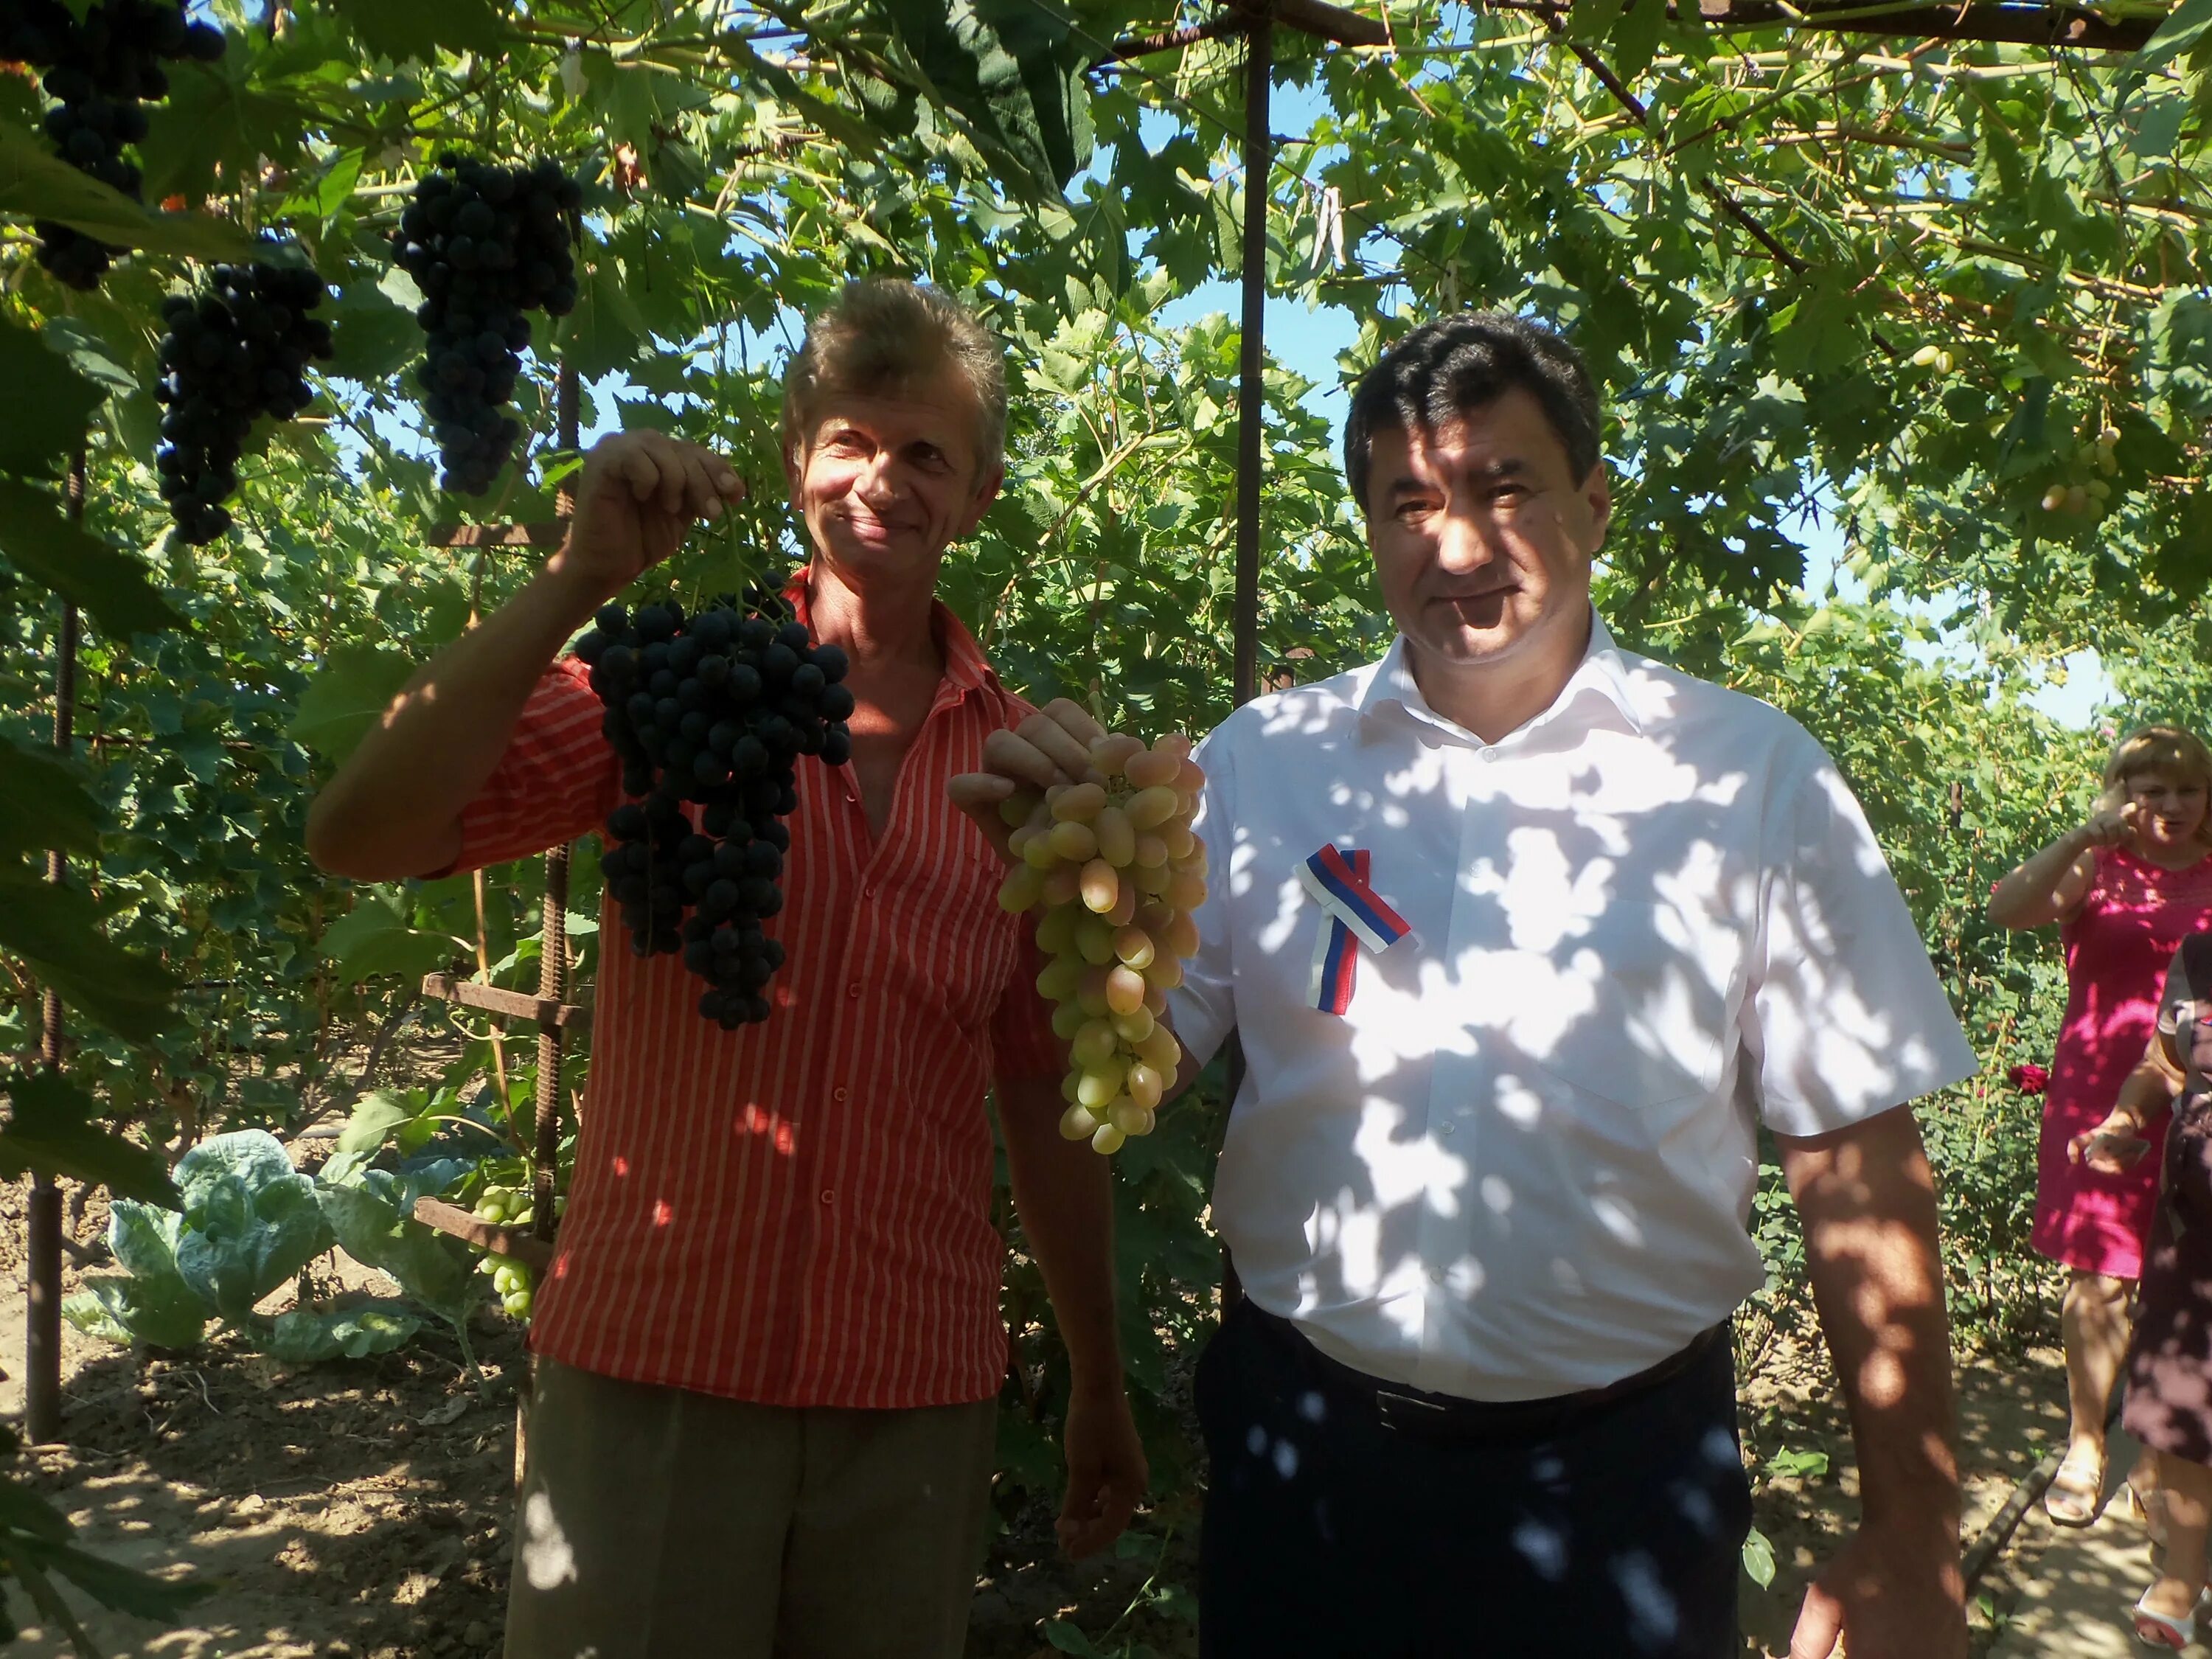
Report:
998,1079,1121,1389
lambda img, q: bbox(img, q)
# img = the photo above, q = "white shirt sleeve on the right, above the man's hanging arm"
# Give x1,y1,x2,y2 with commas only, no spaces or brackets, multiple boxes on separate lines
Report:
1743,739,1980,1135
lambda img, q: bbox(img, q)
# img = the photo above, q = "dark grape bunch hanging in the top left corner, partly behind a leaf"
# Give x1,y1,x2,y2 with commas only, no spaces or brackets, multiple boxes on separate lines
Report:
0,0,223,288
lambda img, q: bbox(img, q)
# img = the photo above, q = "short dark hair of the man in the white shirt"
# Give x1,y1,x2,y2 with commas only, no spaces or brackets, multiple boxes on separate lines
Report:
1345,312,1599,513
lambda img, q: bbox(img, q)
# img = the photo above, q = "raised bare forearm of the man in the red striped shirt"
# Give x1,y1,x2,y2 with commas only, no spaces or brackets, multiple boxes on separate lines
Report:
307,555,604,880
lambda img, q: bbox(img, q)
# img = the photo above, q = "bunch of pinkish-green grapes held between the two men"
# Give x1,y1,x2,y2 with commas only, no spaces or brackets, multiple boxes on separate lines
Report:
998,734,1206,1152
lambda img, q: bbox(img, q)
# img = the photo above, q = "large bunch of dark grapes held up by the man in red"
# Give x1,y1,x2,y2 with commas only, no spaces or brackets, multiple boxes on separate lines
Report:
575,595,852,1031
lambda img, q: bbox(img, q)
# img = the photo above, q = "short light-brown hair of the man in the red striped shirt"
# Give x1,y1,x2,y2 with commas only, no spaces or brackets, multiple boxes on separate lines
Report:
783,276,1006,473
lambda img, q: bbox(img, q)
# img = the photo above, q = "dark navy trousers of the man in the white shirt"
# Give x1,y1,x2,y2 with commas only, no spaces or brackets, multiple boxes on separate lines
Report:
1197,1303,1752,1659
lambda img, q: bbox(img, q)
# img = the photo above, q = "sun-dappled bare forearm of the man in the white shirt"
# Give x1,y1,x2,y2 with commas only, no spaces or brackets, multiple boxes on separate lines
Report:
1781,1108,1960,1546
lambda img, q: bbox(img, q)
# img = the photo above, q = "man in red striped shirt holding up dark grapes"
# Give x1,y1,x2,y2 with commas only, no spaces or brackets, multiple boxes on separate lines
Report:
307,283,1146,1659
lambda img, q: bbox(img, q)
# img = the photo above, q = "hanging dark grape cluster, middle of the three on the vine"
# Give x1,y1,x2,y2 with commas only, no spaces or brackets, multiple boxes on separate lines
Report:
155,263,330,544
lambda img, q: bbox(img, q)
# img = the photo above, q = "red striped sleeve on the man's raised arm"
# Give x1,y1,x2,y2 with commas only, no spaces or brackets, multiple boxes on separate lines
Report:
442,657,622,874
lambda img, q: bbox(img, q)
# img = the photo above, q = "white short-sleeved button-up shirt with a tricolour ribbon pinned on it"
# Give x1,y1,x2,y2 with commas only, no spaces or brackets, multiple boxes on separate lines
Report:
1172,619,1975,1400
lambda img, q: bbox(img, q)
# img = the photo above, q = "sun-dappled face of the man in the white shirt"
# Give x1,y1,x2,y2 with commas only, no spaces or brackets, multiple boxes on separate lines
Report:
1365,387,1613,668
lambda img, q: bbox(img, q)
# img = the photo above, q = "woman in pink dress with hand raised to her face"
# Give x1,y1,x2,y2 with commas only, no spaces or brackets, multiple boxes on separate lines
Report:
1989,726,2212,1526
